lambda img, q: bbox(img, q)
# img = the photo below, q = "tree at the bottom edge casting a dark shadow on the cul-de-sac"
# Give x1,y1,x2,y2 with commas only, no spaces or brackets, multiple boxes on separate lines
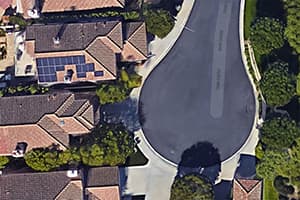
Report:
170,174,214,200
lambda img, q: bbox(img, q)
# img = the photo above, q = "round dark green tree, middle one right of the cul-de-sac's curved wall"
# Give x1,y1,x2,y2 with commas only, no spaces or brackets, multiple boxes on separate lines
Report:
260,62,296,106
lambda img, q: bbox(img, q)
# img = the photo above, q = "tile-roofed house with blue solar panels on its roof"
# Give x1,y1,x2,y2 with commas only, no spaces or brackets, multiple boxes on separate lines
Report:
25,20,148,85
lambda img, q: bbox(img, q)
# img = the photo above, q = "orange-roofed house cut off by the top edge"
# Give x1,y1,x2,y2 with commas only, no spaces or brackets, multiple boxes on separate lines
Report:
21,0,125,18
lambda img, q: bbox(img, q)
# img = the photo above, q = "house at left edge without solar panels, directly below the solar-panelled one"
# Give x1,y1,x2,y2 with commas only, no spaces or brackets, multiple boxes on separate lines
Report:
0,93,99,157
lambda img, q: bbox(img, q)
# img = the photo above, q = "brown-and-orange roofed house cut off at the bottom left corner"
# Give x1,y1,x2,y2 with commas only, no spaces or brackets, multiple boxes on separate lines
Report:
0,167,120,200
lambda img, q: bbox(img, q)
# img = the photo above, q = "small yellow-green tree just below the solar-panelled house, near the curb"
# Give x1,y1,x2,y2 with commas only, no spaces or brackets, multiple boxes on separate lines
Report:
96,83,128,104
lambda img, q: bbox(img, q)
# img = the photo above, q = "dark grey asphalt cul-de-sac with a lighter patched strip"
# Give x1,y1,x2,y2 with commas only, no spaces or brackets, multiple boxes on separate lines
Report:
139,0,255,164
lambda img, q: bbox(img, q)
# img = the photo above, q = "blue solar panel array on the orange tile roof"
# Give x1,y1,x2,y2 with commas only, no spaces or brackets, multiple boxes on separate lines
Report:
36,55,103,82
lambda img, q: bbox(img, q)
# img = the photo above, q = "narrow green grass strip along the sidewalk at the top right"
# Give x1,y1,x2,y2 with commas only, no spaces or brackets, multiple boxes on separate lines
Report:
244,0,257,39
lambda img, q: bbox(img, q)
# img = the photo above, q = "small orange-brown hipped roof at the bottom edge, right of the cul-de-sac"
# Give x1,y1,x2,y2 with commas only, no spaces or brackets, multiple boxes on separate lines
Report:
233,179,262,200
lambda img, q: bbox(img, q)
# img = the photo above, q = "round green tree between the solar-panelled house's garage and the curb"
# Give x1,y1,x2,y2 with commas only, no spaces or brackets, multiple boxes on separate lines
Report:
144,9,175,38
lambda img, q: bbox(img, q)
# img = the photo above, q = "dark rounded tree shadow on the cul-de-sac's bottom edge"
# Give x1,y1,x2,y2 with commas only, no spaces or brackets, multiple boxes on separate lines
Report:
177,141,221,183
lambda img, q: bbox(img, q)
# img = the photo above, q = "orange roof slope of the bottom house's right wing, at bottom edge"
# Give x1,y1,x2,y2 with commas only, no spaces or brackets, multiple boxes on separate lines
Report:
86,186,120,200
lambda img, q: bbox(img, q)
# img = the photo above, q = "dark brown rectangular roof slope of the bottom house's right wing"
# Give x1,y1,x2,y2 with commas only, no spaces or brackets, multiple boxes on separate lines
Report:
87,167,120,187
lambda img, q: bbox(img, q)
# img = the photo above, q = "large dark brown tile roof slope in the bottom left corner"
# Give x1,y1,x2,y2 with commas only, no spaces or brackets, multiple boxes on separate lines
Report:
0,171,82,200
